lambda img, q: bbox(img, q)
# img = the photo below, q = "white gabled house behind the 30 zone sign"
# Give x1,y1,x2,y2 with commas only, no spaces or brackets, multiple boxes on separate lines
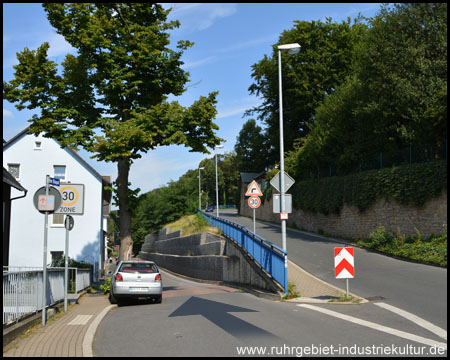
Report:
3,128,111,280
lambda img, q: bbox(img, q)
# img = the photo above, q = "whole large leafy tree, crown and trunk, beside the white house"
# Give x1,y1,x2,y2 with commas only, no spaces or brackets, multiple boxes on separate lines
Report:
3,3,222,259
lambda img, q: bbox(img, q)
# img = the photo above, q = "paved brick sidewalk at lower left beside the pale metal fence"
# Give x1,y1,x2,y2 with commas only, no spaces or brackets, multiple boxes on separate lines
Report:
3,290,116,357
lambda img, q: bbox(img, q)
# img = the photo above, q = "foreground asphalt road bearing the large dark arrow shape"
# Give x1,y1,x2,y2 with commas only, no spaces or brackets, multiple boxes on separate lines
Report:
93,272,446,357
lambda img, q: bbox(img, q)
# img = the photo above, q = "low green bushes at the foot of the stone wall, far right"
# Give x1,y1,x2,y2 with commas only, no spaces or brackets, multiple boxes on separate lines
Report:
358,226,447,266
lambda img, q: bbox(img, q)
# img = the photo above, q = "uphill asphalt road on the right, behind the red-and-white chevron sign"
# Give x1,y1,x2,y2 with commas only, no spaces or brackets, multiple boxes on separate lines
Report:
218,210,447,330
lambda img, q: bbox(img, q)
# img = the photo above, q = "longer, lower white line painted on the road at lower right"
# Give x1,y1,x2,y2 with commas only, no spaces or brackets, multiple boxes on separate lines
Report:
297,304,447,350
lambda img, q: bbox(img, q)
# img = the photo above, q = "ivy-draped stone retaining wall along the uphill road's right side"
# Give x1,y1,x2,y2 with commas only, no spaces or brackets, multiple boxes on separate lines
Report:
241,161,447,238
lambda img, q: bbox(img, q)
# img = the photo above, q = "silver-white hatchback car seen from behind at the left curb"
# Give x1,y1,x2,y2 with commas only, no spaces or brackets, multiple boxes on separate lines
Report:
109,260,163,304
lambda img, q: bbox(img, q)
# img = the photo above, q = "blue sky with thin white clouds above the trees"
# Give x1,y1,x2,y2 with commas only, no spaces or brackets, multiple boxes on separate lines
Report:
3,3,381,202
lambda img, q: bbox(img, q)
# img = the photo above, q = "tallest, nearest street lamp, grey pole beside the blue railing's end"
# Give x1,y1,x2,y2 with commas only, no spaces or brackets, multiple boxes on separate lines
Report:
278,43,300,251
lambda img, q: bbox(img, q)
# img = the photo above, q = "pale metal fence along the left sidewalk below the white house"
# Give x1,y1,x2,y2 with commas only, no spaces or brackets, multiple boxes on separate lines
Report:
3,267,91,325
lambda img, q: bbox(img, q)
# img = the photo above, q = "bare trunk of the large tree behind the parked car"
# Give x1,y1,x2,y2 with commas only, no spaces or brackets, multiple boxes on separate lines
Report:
117,159,133,260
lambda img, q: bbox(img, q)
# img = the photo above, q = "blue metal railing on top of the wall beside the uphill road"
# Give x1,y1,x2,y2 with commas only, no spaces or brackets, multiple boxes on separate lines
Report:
198,210,287,293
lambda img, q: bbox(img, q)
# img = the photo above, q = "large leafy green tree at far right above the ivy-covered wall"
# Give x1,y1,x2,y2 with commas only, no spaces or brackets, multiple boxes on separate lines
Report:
287,3,447,175
